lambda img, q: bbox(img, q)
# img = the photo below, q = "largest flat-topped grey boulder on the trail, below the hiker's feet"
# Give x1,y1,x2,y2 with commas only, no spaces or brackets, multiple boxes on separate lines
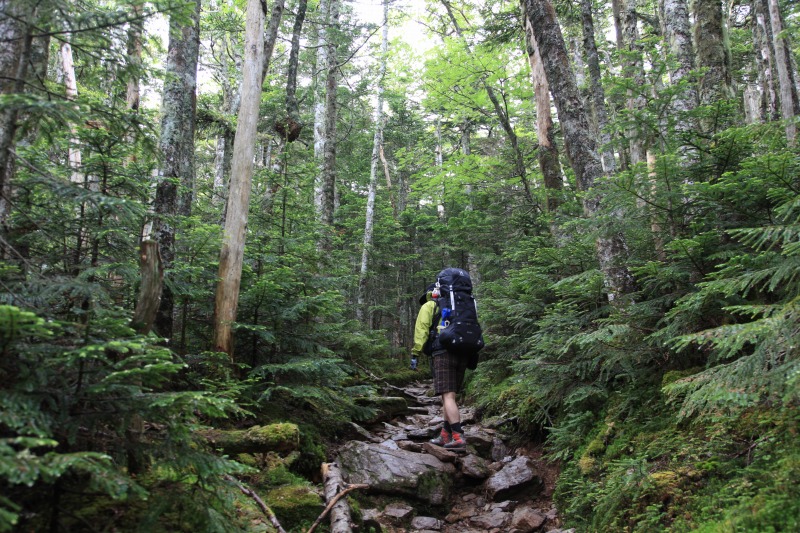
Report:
338,441,455,505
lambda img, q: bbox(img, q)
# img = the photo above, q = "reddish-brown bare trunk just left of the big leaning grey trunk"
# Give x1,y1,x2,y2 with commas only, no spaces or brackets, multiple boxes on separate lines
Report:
521,7,564,212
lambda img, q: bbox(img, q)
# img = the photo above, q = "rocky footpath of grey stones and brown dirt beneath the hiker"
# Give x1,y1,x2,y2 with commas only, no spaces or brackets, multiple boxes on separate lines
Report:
325,382,572,533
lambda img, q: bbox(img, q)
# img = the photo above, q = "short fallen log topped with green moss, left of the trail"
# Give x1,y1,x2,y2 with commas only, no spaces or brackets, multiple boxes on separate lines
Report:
201,423,300,455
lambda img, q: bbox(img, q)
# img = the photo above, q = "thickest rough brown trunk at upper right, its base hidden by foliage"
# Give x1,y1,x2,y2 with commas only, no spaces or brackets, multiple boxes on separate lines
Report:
693,0,731,109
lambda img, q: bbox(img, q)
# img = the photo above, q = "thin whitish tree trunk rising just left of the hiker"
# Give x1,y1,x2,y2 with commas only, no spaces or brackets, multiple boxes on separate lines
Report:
356,0,389,321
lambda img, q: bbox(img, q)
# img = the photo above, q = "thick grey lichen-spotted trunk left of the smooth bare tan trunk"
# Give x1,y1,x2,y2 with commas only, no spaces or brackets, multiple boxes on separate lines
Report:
153,0,200,339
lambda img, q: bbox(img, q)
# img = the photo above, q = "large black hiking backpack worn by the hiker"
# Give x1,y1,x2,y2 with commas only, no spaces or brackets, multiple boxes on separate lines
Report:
436,268,484,357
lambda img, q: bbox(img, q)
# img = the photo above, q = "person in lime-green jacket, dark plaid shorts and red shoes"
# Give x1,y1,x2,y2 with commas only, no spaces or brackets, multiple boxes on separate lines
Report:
411,283,468,450
